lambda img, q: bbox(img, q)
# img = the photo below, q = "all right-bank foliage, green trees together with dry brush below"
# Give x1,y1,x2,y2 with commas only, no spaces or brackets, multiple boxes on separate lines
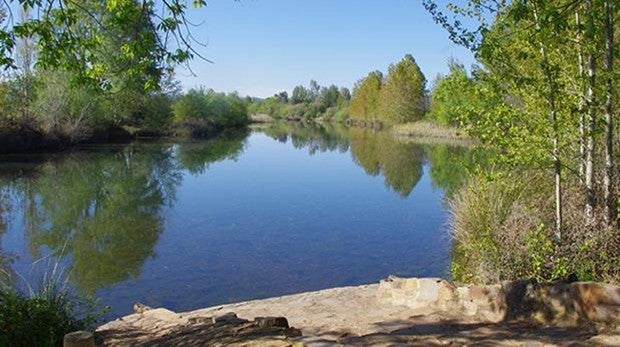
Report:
424,0,619,280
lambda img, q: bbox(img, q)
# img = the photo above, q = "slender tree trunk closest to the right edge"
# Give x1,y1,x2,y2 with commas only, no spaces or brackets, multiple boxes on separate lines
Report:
603,0,618,225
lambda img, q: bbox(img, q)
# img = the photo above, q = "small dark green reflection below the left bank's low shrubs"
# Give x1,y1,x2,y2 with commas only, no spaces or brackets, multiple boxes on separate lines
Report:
176,129,249,174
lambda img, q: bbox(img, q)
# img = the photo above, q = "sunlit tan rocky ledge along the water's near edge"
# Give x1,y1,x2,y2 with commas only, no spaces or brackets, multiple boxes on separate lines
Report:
96,276,620,346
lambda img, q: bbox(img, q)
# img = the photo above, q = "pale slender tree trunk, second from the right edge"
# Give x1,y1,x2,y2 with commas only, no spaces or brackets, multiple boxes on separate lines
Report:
584,0,596,225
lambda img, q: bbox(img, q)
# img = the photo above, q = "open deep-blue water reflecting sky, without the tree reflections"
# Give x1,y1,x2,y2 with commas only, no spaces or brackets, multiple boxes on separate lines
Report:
0,126,464,317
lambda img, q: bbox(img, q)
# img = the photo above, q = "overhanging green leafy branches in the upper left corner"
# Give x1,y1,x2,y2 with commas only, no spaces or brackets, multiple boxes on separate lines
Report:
0,0,206,89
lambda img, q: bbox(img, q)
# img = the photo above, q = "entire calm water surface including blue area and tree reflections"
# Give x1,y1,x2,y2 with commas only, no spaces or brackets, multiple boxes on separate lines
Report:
0,123,470,318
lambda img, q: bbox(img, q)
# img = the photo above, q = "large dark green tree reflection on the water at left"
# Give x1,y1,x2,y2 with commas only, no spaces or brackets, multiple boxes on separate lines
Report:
24,146,180,291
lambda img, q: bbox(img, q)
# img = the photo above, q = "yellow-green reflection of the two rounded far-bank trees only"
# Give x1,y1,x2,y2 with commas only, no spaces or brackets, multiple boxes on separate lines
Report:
349,128,424,197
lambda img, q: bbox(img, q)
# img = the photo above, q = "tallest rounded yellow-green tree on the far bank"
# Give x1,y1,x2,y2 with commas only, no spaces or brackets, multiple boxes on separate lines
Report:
380,54,426,124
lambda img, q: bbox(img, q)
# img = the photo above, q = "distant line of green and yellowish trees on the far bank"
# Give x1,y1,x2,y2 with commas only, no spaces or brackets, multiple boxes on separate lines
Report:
249,54,460,125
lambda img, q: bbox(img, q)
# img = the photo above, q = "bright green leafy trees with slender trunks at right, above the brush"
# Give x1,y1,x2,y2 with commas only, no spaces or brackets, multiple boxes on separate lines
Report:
424,0,617,241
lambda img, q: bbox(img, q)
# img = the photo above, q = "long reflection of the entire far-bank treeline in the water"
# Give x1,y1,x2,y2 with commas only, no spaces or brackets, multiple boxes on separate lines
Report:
263,122,472,197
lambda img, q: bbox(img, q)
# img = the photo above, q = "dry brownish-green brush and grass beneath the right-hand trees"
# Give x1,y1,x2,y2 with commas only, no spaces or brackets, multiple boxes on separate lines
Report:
450,171,620,283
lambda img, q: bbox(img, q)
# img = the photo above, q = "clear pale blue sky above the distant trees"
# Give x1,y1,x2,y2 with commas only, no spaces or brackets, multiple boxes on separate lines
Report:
178,0,474,97
